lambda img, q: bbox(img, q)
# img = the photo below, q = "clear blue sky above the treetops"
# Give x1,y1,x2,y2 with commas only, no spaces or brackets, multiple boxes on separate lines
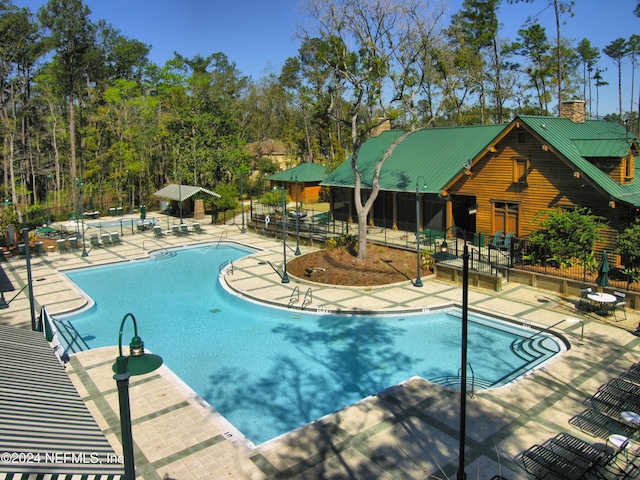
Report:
12,0,640,115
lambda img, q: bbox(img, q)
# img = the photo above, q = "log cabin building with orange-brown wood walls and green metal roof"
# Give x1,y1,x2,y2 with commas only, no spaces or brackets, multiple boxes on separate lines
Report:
322,101,640,248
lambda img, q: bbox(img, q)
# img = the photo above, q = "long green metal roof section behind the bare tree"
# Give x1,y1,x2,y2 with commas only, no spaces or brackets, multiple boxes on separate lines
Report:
322,125,505,193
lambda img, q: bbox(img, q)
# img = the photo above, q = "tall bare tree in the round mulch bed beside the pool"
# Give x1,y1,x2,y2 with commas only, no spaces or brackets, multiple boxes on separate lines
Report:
303,0,444,260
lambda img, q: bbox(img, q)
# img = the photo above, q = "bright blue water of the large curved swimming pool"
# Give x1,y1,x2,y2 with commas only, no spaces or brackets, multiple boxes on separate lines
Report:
58,245,560,444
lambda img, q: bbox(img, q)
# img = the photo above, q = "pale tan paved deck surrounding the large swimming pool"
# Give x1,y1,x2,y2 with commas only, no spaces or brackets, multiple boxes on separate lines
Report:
0,219,640,480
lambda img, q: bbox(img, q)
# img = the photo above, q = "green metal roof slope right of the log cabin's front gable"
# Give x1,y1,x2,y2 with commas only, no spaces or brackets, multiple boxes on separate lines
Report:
514,115,640,207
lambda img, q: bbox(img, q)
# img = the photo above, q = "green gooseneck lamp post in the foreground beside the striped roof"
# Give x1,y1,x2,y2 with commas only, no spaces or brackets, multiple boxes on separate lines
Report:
112,313,162,480
